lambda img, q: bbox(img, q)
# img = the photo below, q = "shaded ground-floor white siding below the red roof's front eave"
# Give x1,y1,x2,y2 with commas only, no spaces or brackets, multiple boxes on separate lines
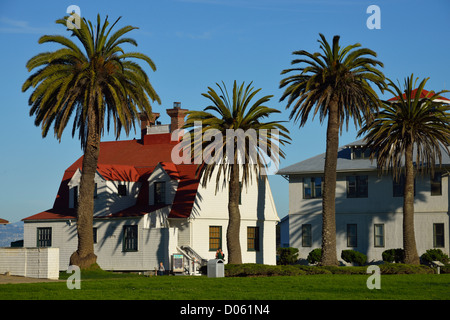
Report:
24,219,178,271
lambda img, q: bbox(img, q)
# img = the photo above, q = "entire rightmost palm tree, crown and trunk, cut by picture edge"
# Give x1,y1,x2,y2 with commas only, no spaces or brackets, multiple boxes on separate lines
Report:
359,75,450,264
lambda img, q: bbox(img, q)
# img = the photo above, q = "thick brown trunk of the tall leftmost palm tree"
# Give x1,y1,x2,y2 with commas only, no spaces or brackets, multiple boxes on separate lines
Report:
70,104,100,269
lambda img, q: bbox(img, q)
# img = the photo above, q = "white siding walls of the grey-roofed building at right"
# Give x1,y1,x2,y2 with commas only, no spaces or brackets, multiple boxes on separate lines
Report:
289,172,450,261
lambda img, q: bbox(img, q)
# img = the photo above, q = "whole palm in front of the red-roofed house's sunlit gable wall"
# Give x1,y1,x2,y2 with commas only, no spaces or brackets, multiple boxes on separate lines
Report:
184,81,290,264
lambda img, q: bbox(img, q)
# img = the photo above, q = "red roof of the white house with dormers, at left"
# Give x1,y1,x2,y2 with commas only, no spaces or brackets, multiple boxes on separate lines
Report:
23,133,199,221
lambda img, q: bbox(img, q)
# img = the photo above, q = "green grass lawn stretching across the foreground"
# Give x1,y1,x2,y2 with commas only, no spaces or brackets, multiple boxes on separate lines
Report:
0,274,450,300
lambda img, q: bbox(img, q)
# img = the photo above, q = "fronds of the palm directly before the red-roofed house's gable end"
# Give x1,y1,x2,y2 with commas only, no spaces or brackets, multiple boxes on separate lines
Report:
184,81,290,188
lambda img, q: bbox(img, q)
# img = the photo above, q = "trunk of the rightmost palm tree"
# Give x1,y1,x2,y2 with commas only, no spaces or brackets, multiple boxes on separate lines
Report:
403,143,420,265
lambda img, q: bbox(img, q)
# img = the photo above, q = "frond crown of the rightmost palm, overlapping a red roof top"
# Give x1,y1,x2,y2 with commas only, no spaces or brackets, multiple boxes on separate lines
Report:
359,75,450,177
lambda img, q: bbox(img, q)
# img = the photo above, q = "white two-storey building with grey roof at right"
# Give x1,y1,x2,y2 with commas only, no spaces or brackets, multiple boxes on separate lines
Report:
278,140,450,261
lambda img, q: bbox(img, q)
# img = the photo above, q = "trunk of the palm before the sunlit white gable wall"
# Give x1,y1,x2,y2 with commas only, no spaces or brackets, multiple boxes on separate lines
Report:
227,164,242,264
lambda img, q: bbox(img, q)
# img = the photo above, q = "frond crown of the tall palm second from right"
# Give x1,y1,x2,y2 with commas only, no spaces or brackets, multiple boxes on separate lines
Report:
280,34,385,130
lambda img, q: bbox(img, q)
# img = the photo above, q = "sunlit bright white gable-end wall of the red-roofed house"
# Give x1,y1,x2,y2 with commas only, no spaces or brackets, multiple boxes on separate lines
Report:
185,170,279,264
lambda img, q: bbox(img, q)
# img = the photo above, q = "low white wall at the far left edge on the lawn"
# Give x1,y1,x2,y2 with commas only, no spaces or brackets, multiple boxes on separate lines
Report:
0,248,59,279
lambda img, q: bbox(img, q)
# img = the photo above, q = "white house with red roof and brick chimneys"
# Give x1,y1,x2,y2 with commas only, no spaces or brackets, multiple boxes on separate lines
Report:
23,106,279,272
